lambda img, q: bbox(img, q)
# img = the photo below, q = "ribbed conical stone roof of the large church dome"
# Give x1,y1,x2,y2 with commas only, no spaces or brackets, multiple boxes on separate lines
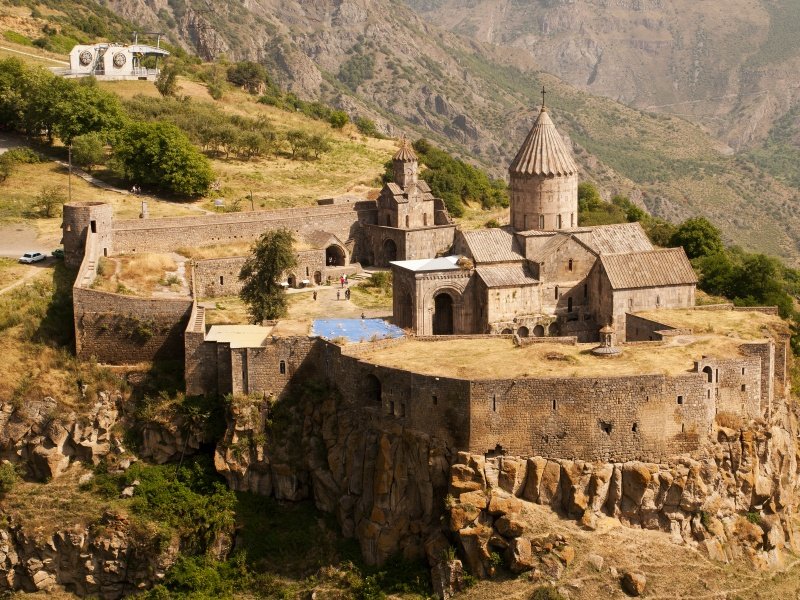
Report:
508,106,578,176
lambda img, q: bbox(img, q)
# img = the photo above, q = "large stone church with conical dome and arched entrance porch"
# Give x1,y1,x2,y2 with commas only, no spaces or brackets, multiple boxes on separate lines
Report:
384,103,697,342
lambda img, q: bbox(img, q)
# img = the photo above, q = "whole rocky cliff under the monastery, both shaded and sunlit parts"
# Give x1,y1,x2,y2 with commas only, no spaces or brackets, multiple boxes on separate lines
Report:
216,380,800,578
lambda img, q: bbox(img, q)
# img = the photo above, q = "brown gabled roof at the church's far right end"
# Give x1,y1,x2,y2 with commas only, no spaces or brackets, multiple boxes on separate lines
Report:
600,248,697,290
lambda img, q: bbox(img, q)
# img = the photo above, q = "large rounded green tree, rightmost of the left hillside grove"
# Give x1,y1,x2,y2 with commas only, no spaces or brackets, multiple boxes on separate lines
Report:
114,122,214,196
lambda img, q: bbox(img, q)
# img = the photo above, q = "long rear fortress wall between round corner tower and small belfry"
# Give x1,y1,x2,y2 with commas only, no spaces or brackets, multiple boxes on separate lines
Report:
114,203,377,254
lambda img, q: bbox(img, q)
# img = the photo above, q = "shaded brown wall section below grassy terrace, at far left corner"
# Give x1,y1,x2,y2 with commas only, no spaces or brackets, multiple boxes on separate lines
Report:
72,287,192,364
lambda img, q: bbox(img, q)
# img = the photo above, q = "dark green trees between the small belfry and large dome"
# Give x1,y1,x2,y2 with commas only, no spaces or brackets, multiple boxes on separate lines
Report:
383,139,509,217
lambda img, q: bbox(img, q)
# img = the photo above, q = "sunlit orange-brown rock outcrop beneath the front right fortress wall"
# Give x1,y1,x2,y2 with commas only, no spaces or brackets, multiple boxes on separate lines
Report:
448,410,800,585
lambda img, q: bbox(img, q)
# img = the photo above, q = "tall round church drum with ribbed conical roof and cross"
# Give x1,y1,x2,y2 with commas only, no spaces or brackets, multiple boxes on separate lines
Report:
508,101,578,231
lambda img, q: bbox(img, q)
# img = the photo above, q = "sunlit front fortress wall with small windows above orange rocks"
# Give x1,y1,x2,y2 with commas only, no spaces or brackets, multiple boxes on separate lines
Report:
469,374,713,462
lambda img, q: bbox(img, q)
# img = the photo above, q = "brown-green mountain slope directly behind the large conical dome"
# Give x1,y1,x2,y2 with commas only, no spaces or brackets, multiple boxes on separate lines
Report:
6,0,800,260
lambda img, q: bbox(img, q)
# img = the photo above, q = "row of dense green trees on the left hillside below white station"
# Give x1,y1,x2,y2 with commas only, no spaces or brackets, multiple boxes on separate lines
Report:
0,58,213,196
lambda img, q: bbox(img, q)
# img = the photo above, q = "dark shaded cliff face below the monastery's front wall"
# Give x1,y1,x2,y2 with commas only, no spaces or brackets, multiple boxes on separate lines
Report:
215,391,453,564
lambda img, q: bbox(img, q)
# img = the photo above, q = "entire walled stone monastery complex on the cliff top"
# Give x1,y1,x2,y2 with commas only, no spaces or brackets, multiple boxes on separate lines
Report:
63,102,788,461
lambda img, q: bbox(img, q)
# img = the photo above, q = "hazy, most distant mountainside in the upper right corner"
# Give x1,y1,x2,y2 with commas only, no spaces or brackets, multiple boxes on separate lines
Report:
406,0,800,149
